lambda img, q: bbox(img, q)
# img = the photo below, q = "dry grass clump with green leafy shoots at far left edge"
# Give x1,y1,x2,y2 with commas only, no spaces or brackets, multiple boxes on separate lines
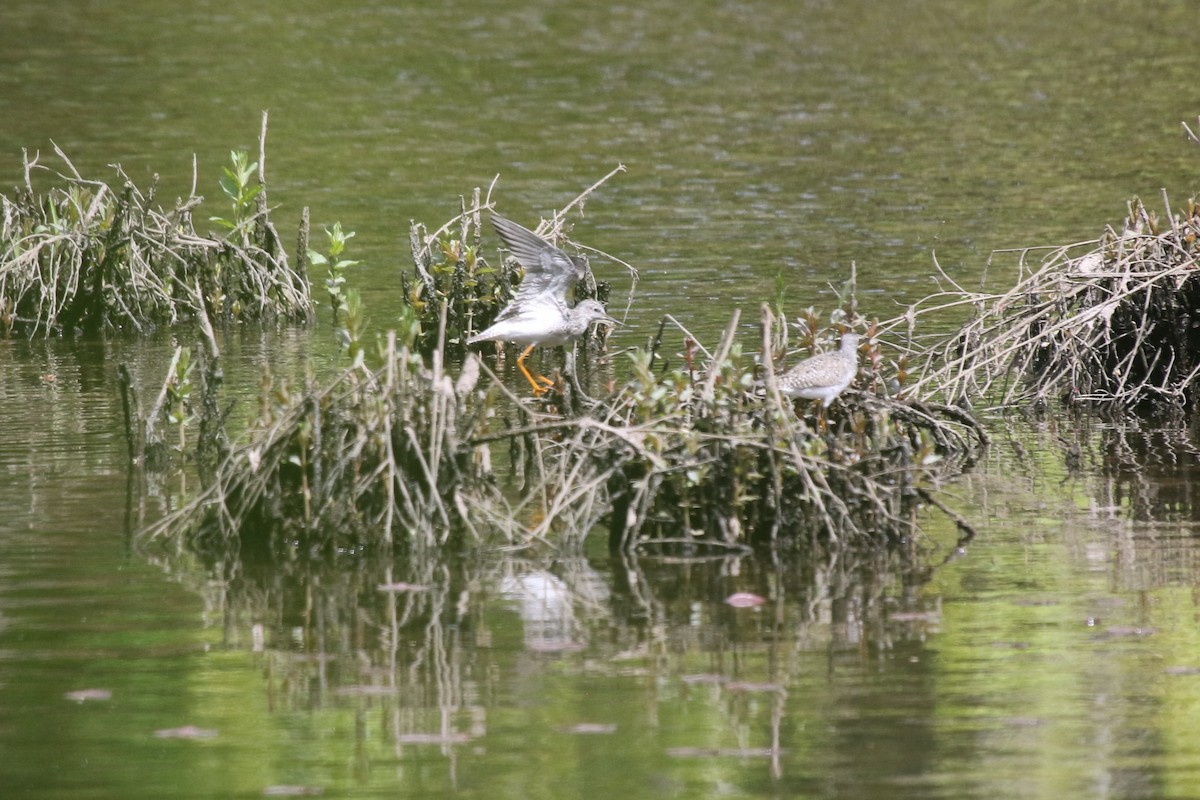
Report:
0,120,312,336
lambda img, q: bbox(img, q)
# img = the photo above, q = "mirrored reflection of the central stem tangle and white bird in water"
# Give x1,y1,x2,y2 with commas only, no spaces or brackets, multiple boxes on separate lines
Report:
157,534,936,786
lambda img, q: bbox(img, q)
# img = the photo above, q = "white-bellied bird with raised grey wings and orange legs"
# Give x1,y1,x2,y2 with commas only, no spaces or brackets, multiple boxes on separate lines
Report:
467,215,620,396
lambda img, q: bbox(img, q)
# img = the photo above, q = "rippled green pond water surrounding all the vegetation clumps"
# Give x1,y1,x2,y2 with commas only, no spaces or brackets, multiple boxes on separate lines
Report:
0,0,1200,799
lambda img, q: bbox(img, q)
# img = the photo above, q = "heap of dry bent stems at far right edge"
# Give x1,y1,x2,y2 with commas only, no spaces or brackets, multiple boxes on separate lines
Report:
917,193,1200,410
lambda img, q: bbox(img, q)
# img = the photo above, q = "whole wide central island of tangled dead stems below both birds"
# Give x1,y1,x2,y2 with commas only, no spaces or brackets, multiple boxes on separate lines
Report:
140,297,985,555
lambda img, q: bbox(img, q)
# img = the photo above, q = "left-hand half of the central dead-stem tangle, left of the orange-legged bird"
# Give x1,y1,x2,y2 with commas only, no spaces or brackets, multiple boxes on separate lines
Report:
142,321,496,555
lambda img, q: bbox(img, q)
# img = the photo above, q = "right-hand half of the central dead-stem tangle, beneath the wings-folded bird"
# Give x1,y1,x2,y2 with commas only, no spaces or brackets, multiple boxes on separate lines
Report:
528,307,986,552
